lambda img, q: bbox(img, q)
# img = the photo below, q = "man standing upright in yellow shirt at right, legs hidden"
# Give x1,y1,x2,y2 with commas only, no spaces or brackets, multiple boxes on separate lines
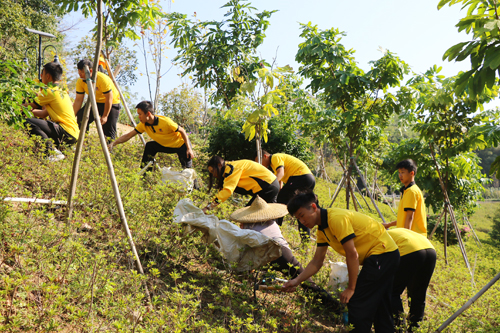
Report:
384,159,427,237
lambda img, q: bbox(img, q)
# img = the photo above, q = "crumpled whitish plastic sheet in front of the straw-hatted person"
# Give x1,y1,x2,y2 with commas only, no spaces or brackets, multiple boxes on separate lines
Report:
174,199,281,272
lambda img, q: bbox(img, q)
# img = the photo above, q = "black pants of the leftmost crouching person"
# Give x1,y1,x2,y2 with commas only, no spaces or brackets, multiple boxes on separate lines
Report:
26,118,77,150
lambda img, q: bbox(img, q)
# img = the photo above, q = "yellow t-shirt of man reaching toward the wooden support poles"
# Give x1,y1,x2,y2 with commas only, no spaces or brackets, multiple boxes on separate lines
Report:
135,116,184,148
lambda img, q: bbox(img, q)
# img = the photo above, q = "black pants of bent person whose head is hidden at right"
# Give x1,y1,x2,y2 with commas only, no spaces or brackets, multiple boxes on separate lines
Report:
391,249,436,331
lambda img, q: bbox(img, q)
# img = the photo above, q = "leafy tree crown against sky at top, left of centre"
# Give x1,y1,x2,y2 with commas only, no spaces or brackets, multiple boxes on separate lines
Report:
169,0,275,109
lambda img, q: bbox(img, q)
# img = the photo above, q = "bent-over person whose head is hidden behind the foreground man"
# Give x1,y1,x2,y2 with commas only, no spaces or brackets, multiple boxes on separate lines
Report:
387,228,436,332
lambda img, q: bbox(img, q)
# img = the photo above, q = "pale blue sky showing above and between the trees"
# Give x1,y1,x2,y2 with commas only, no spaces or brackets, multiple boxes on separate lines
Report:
65,0,492,104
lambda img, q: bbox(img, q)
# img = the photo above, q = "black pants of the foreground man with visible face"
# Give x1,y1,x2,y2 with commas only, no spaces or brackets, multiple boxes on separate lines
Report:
347,250,399,333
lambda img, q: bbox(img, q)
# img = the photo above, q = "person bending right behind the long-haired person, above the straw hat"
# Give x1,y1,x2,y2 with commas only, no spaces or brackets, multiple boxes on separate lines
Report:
254,150,316,240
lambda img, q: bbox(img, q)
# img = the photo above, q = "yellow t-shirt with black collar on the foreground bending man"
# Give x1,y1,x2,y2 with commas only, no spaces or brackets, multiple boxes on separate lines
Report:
316,208,398,265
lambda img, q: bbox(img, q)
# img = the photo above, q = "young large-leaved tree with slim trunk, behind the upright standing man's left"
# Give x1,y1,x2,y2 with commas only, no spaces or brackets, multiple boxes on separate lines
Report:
296,22,412,209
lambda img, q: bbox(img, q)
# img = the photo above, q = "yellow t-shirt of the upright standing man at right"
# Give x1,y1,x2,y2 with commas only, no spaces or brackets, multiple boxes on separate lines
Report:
396,183,427,237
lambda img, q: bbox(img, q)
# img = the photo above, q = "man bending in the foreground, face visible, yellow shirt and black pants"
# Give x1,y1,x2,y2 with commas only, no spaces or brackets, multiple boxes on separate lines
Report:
283,191,399,333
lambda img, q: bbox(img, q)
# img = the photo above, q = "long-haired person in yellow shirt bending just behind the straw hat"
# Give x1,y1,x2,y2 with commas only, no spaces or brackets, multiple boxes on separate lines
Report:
203,156,279,213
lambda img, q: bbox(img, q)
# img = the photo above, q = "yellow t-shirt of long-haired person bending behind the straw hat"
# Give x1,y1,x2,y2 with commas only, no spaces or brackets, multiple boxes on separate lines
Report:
217,160,276,202
